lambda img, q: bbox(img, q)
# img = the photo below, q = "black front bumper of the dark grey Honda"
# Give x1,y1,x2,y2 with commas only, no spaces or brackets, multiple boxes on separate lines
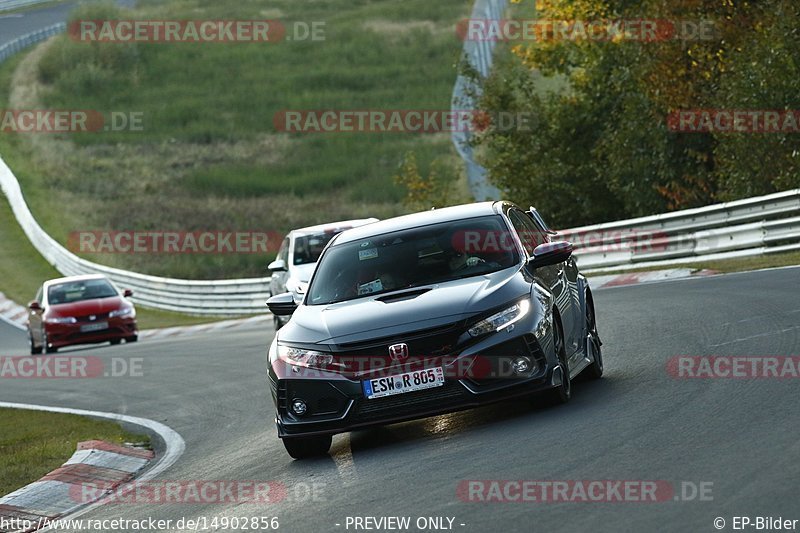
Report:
269,331,557,438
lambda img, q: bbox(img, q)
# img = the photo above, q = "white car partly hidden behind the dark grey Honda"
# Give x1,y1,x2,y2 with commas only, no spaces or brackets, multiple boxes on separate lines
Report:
267,218,378,329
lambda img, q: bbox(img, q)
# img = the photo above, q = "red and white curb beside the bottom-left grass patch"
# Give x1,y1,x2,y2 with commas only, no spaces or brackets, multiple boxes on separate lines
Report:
0,441,155,533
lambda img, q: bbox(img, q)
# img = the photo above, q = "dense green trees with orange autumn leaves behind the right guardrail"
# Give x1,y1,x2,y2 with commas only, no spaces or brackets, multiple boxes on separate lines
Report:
474,0,800,227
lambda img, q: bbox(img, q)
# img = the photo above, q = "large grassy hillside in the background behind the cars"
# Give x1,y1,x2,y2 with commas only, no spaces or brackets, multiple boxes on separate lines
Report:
0,0,471,279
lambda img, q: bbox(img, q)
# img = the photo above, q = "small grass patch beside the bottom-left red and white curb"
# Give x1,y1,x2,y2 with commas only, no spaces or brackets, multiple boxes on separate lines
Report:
0,409,150,496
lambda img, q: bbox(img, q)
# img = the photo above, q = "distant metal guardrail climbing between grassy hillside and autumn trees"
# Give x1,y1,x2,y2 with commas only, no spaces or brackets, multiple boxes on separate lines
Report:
451,0,508,202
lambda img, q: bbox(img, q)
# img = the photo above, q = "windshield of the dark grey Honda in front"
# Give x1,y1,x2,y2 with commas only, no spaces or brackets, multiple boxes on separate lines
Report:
307,215,519,305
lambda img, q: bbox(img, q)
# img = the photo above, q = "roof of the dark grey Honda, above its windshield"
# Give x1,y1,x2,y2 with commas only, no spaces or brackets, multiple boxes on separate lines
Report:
334,201,513,245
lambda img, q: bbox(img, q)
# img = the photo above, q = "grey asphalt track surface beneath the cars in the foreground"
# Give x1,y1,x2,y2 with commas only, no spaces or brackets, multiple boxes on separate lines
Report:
0,268,800,532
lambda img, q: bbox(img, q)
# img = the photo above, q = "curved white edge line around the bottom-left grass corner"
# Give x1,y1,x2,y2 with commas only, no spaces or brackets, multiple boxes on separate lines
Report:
0,402,186,531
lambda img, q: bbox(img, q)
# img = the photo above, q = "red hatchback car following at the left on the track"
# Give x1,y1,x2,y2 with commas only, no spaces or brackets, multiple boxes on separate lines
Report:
28,275,139,354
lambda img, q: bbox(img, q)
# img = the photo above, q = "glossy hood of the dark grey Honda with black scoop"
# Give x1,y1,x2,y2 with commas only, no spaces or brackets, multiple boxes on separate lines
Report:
279,266,530,344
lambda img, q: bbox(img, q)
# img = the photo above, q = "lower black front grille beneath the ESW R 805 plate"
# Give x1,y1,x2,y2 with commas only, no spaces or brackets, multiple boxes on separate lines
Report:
354,381,471,422
